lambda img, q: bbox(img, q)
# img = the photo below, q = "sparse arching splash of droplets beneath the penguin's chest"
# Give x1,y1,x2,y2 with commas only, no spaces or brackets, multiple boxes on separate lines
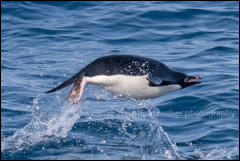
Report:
116,101,184,160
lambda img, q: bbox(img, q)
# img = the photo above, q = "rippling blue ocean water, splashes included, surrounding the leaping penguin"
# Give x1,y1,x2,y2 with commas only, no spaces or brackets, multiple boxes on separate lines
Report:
1,1,239,160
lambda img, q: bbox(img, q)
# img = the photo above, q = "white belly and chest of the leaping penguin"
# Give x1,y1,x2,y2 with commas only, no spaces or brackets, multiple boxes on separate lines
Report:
85,75,181,99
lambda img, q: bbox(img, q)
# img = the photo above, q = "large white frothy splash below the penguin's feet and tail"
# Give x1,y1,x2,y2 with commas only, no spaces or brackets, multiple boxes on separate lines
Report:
1,97,81,152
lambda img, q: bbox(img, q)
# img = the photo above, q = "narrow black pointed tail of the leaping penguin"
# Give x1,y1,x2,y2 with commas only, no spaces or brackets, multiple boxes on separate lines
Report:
44,72,84,93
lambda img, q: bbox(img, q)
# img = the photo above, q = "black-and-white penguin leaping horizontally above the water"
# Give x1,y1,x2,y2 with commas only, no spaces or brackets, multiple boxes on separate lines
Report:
45,55,201,104
